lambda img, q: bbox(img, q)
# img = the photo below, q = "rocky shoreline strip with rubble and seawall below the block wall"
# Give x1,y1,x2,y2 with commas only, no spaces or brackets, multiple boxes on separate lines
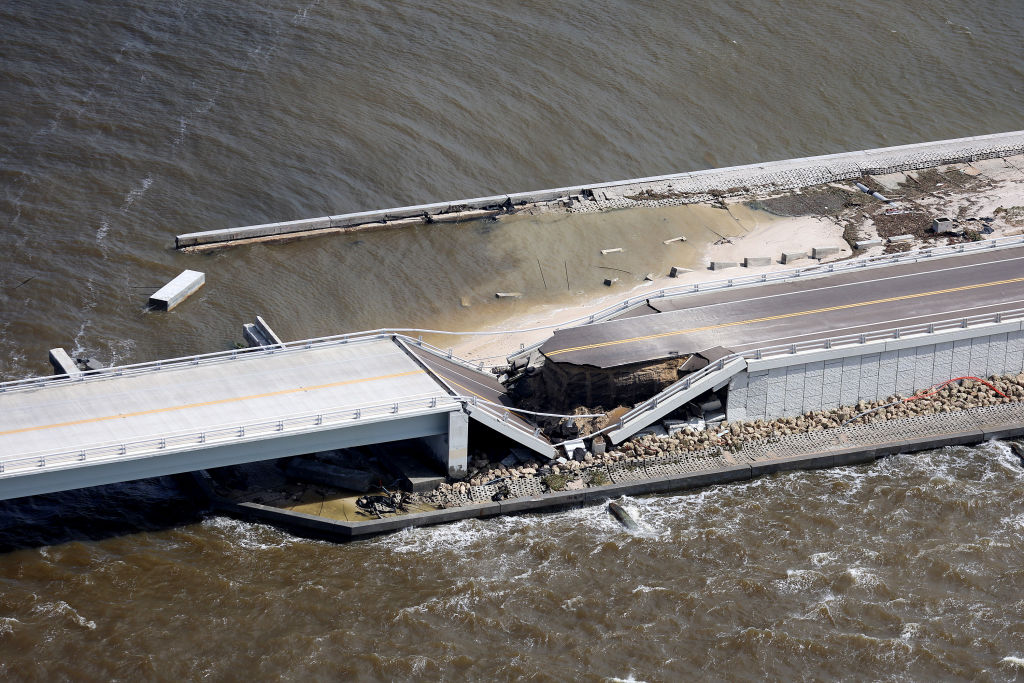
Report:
203,374,1024,541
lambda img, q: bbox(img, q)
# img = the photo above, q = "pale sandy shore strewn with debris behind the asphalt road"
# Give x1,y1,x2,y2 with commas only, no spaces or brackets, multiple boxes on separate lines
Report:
445,155,1024,360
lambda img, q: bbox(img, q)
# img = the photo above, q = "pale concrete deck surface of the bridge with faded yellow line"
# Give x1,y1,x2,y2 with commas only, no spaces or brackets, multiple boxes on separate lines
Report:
0,339,458,464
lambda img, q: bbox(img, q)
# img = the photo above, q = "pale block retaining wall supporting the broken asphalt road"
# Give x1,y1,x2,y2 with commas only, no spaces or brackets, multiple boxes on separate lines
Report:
726,321,1024,420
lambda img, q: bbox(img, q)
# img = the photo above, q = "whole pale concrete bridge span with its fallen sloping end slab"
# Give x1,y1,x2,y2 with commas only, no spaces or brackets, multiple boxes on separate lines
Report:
0,335,553,500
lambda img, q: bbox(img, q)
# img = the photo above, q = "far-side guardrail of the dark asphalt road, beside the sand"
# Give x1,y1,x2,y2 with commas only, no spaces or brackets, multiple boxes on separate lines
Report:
508,236,1024,360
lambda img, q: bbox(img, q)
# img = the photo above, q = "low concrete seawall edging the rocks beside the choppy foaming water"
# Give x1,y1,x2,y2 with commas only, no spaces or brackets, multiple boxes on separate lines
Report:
200,402,1024,541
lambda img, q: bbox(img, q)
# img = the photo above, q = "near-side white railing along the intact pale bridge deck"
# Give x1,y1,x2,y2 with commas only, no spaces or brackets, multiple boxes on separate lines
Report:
0,394,460,476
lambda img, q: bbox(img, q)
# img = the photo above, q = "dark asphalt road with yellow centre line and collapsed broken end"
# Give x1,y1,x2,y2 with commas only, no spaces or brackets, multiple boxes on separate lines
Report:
540,242,1024,368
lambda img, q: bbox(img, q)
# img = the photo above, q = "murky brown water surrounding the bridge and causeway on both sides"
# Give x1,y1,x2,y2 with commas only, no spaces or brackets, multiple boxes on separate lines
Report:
0,0,1024,680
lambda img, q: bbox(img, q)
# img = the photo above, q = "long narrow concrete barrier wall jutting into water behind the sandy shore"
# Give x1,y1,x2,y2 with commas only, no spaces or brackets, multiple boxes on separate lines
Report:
175,131,1024,249
